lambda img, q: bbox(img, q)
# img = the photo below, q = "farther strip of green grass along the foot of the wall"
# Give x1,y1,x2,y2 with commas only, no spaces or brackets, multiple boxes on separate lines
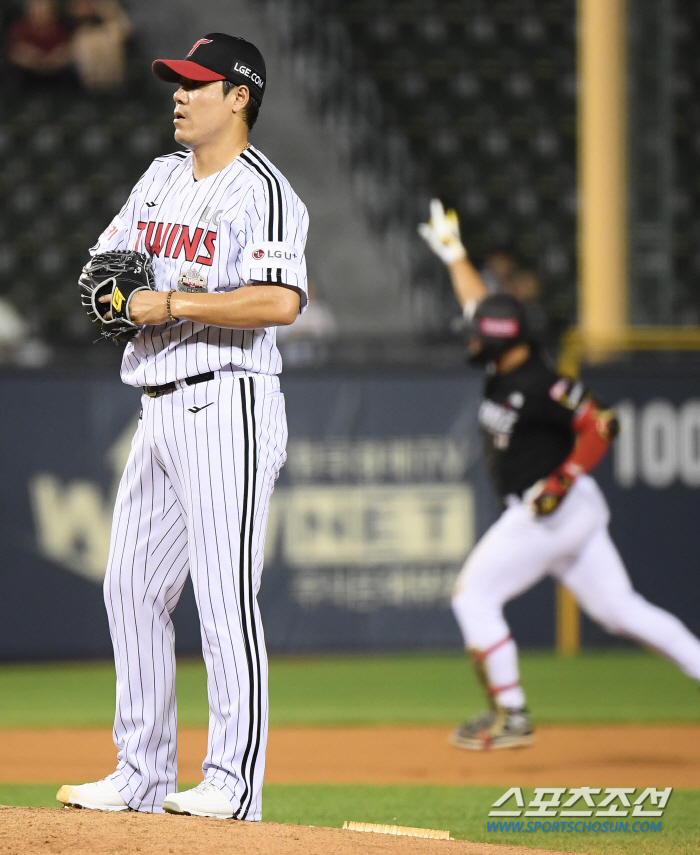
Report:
0,650,700,727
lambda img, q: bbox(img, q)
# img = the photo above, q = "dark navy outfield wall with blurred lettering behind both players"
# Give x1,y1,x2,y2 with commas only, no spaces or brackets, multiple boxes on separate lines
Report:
0,369,700,660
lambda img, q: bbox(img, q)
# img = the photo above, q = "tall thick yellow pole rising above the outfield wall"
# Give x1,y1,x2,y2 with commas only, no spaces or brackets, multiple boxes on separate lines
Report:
578,0,628,360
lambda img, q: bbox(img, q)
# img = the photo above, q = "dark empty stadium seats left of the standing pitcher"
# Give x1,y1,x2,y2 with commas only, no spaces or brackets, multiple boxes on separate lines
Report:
0,54,173,344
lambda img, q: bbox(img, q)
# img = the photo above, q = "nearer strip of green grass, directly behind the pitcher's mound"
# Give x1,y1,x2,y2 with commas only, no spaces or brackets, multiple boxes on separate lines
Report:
0,784,700,855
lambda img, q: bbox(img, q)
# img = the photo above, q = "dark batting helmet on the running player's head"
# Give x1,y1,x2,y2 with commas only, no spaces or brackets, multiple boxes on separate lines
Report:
466,294,529,365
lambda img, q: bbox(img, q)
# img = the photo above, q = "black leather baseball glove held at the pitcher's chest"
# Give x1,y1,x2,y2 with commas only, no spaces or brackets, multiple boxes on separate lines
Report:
78,250,155,342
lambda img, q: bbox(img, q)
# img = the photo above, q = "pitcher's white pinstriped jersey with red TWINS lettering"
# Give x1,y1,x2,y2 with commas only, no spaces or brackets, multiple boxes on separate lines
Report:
90,146,309,386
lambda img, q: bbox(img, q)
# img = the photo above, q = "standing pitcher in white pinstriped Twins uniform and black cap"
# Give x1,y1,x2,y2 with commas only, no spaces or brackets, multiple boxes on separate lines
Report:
58,33,308,820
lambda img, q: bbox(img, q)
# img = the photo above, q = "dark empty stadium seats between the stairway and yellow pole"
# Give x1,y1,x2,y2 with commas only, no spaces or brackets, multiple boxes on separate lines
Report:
268,0,576,332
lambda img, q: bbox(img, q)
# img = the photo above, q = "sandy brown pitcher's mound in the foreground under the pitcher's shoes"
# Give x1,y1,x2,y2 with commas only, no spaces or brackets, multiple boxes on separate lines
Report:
0,807,572,855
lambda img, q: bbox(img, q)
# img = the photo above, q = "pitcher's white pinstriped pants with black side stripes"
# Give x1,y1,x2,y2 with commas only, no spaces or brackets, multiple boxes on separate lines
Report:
104,375,287,820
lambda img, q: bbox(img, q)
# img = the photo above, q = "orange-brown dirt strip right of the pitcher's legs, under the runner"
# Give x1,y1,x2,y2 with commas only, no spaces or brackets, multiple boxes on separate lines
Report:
266,725,700,787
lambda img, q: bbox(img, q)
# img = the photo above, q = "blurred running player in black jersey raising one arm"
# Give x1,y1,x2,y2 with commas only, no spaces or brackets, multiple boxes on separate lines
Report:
419,200,700,750
